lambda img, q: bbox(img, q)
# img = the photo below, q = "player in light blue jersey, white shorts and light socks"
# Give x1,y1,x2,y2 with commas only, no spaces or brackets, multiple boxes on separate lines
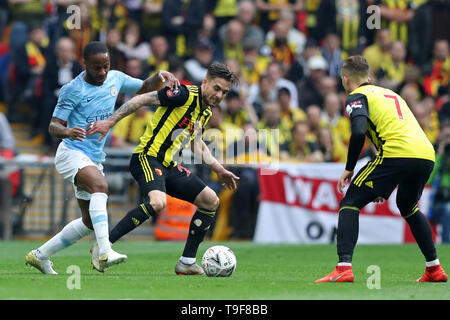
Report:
25,41,179,274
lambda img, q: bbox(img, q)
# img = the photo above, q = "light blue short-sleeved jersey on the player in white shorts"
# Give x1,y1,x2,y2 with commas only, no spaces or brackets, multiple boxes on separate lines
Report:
53,70,143,162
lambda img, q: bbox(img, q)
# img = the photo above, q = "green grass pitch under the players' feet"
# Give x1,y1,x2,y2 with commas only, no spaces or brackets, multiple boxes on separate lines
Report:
0,241,450,300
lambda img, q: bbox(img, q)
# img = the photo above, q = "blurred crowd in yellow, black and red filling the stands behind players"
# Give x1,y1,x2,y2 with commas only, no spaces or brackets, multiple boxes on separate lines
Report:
0,0,450,238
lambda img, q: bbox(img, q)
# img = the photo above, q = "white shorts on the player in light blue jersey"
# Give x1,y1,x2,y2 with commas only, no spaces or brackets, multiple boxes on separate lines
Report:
55,141,105,200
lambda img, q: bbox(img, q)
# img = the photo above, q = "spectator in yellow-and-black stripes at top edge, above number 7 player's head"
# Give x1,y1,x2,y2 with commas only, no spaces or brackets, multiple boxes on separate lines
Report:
317,0,367,59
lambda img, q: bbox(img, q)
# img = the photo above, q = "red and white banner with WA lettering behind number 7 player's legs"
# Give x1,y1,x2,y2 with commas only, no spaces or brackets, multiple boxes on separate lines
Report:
253,161,430,244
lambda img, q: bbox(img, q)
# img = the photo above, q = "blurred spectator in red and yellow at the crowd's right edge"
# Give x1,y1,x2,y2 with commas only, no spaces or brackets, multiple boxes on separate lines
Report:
423,40,450,96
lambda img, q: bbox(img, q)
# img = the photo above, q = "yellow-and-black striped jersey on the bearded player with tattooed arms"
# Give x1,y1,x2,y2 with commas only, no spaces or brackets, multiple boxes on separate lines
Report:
134,85,212,167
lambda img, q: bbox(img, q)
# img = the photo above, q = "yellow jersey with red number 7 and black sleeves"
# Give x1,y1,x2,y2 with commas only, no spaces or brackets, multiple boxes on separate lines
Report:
345,84,435,161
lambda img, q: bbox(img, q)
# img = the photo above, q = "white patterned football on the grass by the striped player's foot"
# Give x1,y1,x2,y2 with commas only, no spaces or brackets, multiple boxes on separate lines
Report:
202,246,237,277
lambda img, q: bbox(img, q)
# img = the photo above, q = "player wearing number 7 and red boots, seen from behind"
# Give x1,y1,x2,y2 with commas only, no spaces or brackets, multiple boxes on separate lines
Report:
315,56,447,282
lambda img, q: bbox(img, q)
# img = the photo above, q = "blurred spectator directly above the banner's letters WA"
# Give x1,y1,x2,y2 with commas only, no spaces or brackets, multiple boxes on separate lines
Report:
281,121,323,162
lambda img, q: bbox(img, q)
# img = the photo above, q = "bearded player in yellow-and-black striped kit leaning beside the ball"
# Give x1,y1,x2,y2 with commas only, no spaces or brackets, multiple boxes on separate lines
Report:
87,63,239,275
